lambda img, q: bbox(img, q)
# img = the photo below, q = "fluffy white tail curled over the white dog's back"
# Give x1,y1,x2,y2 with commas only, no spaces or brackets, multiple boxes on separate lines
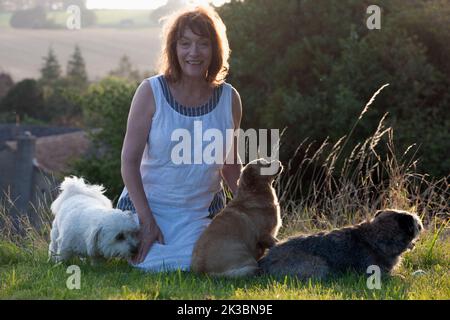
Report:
50,176,112,214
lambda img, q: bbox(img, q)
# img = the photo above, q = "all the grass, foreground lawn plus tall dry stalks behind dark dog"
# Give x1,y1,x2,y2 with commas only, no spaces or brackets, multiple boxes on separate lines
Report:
0,84,450,300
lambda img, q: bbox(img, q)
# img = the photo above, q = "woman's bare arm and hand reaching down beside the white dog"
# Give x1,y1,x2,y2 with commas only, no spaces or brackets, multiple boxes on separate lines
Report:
121,80,163,262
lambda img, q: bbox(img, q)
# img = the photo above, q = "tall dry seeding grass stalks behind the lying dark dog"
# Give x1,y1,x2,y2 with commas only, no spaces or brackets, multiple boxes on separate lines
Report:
276,85,450,235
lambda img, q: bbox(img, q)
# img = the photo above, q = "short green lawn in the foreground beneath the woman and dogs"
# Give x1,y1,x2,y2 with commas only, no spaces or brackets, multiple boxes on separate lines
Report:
0,230,450,300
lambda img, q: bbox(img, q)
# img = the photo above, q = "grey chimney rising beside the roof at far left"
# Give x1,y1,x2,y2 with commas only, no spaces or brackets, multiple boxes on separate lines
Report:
13,131,36,214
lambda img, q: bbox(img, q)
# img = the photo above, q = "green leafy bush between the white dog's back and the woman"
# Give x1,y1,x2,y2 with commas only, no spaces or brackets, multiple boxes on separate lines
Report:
68,77,137,199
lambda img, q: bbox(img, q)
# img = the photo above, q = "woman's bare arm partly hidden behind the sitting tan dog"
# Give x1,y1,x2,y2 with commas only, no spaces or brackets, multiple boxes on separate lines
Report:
222,88,242,195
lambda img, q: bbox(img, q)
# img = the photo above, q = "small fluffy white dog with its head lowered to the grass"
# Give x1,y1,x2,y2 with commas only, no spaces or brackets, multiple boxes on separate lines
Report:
49,177,139,263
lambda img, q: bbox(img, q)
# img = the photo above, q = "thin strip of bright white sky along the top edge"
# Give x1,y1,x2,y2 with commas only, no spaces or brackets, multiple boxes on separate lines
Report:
86,0,229,10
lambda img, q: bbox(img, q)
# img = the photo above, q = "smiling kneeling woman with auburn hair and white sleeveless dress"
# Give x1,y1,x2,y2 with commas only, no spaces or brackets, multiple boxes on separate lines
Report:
118,7,242,271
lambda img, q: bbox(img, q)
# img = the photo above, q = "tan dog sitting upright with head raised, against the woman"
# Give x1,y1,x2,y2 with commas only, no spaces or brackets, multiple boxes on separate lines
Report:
191,159,282,277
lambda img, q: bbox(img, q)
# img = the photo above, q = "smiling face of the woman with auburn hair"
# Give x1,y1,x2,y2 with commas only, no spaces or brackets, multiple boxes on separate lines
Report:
177,28,212,79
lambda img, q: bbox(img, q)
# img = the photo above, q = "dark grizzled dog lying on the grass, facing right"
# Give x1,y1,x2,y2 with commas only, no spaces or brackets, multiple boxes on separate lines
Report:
259,209,423,279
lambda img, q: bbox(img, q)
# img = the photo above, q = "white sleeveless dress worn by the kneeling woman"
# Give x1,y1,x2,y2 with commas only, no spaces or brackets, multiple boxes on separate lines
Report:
117,75,234,272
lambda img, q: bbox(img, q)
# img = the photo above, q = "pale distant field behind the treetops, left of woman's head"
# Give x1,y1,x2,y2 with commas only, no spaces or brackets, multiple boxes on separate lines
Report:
0,11,161,81
